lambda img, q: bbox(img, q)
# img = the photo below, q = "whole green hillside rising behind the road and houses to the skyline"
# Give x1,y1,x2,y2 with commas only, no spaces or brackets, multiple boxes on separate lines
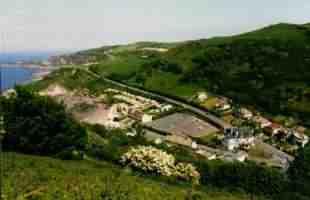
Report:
75,24,310,125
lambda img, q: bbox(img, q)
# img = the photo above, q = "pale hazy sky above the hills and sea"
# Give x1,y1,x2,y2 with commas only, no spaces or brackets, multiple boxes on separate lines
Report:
0,0,310,52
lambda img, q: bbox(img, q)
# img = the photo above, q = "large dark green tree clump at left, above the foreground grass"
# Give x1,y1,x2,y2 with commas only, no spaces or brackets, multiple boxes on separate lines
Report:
1,87,87,155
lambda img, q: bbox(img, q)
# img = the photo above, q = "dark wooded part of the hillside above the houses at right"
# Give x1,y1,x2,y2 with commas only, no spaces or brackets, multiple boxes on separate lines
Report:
177,30,310,125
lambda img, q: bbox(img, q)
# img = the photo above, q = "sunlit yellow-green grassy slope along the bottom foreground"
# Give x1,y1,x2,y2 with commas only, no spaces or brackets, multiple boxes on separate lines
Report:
3,153,256,200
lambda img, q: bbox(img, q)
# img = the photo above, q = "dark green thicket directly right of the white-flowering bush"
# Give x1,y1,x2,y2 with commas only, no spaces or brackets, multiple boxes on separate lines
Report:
198,161,287,196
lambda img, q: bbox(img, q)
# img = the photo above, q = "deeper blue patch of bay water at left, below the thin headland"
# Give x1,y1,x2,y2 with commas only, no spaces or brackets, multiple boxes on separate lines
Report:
0,66,35,91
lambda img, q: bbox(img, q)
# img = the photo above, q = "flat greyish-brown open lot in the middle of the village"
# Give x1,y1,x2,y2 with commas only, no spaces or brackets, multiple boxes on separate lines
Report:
146,113,218,138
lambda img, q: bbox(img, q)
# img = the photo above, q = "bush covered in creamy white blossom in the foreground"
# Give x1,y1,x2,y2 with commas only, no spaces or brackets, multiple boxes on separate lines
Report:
121,146,200,183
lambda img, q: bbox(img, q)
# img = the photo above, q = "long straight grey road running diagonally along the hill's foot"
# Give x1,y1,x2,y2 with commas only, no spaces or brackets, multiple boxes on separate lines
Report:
80,68,232,129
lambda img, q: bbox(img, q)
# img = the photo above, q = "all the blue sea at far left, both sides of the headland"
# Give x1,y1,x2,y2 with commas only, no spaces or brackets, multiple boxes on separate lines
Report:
0,52,53,91
